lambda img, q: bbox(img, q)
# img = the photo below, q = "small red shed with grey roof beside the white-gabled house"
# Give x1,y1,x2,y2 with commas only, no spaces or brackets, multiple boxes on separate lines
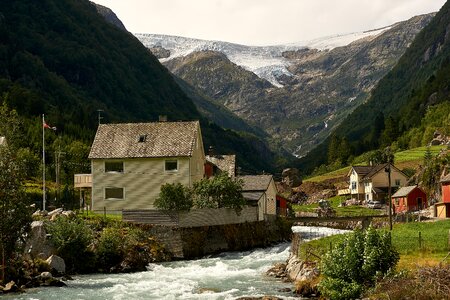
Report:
392,185,428,213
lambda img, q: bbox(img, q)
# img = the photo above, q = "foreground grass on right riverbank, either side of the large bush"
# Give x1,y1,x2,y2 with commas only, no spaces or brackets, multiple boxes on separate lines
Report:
299,220,450,268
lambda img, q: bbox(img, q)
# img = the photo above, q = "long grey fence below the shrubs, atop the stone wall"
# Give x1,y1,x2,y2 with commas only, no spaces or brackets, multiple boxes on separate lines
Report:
122,207,258,227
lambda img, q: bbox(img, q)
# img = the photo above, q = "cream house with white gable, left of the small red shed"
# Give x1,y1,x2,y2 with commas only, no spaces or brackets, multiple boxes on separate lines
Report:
347,164,408,201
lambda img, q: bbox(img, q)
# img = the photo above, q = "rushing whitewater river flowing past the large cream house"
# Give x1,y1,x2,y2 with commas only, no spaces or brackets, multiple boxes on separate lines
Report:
5,226,348,300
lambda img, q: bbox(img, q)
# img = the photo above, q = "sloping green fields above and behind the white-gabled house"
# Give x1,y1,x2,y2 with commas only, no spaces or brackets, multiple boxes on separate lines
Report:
304,146,447,182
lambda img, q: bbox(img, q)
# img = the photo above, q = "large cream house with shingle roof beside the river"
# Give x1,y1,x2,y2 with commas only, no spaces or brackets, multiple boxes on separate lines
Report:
89,121,205,211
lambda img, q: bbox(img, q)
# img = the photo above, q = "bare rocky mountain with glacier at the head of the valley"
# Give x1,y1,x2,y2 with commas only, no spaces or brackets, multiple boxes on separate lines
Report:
142,14,434,156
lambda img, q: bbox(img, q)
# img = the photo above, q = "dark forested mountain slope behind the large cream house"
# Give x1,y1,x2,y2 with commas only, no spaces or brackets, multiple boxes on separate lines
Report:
0,0,280,170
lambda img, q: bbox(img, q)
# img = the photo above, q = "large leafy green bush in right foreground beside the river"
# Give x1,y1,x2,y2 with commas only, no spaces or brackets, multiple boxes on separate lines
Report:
319,227,399,299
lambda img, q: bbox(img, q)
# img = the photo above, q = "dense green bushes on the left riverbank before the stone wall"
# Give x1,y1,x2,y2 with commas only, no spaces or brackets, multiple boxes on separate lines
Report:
46,217,170,273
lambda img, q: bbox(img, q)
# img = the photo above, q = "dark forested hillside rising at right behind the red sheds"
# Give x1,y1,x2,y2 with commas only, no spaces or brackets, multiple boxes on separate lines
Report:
301,2,450,171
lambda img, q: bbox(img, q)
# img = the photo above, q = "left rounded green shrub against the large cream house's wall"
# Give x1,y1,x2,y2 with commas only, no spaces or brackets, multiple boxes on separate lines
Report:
154,183,192,211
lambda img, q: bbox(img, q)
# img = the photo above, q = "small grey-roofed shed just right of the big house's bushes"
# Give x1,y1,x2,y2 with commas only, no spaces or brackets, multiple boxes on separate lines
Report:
237,175,277,220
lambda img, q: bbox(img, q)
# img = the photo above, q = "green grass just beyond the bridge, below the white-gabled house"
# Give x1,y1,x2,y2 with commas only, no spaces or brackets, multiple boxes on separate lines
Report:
292,196,385,217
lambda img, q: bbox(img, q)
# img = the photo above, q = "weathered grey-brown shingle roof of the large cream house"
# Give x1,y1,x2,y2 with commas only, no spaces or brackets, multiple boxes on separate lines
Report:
89,121,203,159
